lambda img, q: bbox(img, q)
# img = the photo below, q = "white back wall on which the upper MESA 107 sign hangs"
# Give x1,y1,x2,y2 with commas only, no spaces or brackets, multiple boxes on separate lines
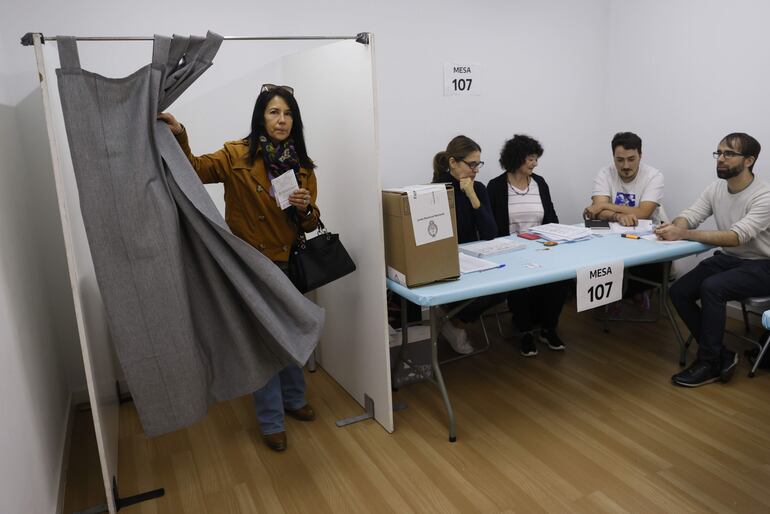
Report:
0,0,609,220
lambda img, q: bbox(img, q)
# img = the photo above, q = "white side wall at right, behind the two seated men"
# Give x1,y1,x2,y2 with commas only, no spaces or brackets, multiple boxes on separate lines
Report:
603,0,770,217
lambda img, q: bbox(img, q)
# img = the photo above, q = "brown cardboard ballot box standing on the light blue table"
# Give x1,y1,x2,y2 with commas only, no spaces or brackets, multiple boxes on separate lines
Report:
382,184,460,287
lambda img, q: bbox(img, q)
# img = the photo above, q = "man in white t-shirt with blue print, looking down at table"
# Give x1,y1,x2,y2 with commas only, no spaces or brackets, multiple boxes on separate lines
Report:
583,132,665,226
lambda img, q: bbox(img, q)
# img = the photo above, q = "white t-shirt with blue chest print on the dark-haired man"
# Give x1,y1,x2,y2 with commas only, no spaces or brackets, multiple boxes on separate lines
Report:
591,162,670,223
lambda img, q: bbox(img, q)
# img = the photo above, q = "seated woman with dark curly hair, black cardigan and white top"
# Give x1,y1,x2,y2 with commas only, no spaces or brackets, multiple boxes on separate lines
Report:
487,135,570,357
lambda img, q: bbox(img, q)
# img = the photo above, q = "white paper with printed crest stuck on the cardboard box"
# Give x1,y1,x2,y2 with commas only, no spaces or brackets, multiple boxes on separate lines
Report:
406,184,454,246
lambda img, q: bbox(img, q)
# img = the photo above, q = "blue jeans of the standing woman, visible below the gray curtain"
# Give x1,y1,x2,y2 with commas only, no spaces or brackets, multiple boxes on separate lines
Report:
252,364,307,435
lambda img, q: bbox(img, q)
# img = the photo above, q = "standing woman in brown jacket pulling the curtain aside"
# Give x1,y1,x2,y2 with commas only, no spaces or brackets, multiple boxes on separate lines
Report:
158,84,319,451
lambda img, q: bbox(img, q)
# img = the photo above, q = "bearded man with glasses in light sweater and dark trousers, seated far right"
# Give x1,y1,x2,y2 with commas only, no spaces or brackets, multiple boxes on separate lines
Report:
655,132,770,387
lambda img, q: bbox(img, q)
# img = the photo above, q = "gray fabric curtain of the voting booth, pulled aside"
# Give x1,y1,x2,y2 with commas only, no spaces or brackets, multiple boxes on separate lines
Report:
56,33,324,436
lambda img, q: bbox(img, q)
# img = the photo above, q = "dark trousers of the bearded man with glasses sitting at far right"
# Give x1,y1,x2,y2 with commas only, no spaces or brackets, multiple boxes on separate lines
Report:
670,251,770,363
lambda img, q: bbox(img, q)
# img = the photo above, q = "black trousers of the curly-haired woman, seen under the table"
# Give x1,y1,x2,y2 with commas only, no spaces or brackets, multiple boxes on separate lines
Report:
508,280,572,332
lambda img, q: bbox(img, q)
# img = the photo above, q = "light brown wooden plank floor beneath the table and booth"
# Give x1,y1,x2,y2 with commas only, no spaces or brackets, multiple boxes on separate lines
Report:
65,305,770,514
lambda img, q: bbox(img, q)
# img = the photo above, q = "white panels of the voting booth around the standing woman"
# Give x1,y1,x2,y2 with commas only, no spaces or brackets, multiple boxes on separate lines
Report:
25,33,393,513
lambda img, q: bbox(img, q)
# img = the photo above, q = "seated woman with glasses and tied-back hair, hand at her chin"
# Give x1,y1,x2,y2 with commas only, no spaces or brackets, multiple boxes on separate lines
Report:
433,136,496,354
